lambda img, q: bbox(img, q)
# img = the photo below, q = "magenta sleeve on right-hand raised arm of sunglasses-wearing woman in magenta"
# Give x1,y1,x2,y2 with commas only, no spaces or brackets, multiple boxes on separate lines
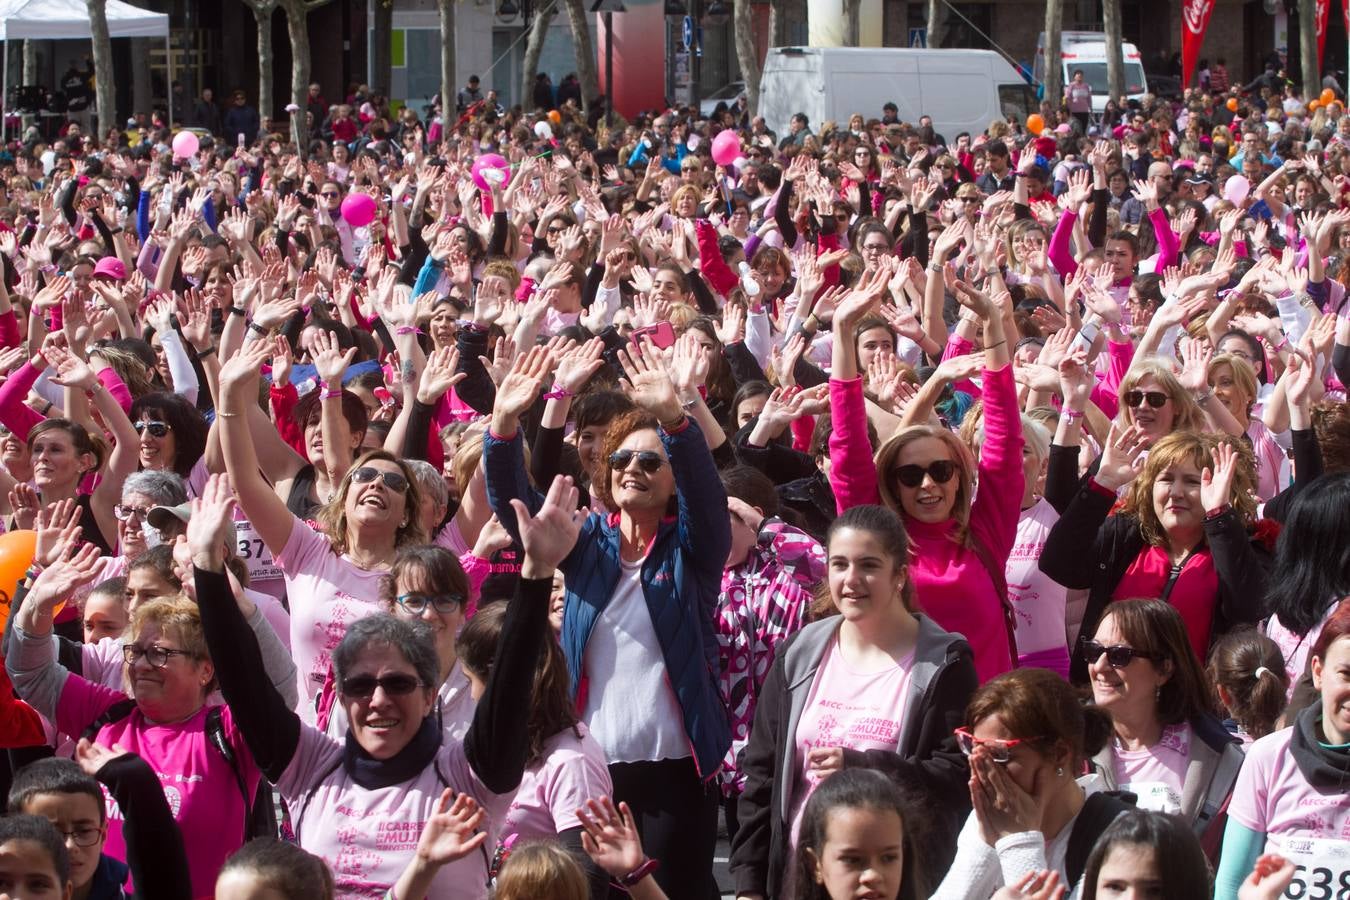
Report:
966,366,1023,560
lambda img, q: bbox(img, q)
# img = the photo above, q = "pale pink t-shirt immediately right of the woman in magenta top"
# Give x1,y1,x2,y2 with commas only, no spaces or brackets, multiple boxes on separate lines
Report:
1004,498,1069,679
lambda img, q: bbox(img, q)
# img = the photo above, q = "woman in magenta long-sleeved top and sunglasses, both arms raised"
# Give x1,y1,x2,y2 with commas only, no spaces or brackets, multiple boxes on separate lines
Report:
830,273,1023,683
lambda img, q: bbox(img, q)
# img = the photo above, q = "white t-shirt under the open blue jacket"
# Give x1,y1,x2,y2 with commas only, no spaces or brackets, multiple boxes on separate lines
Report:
582,563,693,762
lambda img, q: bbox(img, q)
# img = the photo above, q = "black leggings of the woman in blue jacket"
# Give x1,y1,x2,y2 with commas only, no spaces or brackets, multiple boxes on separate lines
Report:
609,757,721,900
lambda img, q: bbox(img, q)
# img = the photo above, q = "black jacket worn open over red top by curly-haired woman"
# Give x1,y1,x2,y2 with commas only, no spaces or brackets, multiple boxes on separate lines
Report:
1041,482,1270,681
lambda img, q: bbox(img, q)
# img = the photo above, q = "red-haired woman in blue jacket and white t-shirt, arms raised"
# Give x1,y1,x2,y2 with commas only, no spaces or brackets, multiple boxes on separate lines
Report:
483,341,732,897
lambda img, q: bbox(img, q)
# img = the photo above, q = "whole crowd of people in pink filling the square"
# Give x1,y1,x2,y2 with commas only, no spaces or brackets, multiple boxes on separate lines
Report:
0,66,1350,900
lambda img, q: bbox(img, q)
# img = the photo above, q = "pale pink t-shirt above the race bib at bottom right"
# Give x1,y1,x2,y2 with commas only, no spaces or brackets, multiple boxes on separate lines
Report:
1229,727,1350,841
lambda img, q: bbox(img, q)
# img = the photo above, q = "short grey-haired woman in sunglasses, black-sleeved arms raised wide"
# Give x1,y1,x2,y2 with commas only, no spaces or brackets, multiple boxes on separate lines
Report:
188,476,575,900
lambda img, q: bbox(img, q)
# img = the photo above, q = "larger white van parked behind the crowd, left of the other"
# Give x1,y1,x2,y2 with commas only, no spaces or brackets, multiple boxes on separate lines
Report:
759,47,1035,140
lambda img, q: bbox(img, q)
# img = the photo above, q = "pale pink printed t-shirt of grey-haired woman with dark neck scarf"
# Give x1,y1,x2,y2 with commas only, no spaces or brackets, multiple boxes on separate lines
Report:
277,726,510,900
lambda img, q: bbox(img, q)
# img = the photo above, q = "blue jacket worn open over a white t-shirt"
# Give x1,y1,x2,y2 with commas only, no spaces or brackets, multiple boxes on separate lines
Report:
483,420,732,780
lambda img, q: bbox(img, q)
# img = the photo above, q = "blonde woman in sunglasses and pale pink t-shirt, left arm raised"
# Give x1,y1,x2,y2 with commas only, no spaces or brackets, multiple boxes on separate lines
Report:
216,340,425,723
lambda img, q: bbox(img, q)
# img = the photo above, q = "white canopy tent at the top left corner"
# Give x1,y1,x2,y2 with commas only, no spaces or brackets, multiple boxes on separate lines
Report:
0,0,173,135
